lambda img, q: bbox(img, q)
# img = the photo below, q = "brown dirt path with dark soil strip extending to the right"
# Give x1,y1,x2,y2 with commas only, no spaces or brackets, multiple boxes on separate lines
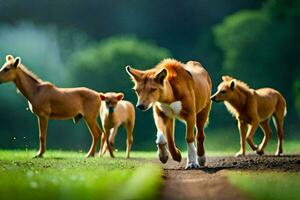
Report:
160,155,300,200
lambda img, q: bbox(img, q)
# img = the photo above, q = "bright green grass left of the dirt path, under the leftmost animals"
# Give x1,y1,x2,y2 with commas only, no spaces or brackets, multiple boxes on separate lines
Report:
0,150,162,199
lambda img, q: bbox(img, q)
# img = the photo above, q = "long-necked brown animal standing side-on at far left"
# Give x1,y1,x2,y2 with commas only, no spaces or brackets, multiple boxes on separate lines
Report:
0,55,111,157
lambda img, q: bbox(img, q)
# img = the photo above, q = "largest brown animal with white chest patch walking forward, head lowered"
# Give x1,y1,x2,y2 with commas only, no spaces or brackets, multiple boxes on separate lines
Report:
126,59,212,169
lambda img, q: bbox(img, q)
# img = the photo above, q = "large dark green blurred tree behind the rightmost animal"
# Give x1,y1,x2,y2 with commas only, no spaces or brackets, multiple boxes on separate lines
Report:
214,0,300,122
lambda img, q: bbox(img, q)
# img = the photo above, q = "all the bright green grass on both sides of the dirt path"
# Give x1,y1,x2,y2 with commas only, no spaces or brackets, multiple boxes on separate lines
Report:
0,140,300,200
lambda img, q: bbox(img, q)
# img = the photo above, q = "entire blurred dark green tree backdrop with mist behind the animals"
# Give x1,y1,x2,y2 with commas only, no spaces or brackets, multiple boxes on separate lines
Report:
0,0,300,150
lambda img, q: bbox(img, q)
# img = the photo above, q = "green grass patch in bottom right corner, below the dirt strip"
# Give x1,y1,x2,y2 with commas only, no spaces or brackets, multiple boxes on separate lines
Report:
227,171,300,200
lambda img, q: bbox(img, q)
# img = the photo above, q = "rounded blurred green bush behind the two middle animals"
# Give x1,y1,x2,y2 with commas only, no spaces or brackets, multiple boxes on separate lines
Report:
68,36,171,94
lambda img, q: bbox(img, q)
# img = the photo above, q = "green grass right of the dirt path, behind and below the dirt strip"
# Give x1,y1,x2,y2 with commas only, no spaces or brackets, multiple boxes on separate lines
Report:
211,137,300,200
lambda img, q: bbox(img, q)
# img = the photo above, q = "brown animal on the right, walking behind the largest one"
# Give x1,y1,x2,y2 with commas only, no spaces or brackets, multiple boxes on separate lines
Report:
211,76,287,156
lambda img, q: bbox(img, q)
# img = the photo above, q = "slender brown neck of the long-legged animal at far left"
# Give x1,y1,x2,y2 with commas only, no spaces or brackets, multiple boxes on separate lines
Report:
14,69,39,102
